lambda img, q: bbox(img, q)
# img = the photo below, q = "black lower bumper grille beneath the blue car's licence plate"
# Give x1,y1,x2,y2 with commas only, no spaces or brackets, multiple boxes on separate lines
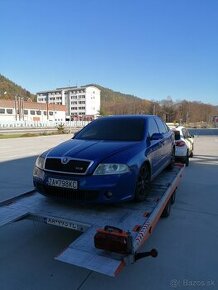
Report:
36,183,99,202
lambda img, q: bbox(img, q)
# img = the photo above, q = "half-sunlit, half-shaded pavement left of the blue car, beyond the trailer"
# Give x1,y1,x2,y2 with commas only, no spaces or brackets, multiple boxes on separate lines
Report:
0,134,72,201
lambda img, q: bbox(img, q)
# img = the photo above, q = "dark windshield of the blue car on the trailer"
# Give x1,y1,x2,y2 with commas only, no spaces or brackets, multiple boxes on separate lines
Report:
75,118,145,141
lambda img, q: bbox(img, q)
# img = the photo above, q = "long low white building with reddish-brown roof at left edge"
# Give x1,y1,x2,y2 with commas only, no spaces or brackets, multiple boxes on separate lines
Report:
0,98,66,122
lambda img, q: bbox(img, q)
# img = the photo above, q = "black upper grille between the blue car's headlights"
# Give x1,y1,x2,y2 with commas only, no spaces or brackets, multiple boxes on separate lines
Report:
45,158,91,174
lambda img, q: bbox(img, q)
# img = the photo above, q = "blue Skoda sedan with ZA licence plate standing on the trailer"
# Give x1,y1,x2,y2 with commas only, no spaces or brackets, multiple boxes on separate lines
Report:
33,115,175,203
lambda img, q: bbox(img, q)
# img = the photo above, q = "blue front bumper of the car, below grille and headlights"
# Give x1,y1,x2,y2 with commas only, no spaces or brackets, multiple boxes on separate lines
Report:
33,170,136,203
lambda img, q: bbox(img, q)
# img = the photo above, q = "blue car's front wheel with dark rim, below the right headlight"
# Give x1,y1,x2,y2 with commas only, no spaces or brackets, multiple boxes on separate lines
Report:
135,163,151,202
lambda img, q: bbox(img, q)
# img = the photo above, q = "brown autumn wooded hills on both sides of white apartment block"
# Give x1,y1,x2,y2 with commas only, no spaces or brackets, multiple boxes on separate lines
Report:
0,74,218,124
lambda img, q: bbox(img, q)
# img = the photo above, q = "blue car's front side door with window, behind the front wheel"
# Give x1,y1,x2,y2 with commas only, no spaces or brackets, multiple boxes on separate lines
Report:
147,117,163,175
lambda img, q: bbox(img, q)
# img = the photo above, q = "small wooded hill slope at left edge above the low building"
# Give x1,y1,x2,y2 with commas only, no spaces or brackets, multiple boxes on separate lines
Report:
0,74,35,100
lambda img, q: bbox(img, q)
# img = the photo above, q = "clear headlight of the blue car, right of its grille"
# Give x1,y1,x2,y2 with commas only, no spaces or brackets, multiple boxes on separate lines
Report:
93,163,129,175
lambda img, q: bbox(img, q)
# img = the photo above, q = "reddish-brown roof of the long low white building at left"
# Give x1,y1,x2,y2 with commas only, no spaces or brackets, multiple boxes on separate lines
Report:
0,99,66,111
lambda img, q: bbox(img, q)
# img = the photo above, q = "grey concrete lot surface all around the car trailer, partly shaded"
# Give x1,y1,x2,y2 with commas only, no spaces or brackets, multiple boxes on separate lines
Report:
0,135,218,290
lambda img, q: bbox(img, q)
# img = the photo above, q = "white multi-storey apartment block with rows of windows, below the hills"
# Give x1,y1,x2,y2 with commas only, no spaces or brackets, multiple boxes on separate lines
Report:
37,85,101,119
